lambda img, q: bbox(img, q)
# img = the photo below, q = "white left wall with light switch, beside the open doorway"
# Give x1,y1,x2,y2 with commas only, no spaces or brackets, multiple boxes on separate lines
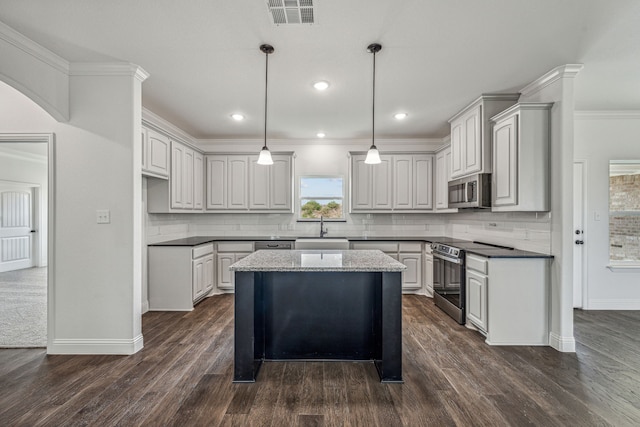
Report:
0,26,146,354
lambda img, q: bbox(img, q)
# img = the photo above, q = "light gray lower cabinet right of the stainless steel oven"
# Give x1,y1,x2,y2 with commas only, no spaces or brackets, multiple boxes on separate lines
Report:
466,254,551,345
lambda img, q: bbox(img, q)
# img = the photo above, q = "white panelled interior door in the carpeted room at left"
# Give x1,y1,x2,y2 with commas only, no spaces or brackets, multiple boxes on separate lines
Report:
0,186,34,272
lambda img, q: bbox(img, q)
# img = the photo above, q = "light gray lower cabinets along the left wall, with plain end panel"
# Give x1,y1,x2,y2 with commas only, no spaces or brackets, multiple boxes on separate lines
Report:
148,243,215,311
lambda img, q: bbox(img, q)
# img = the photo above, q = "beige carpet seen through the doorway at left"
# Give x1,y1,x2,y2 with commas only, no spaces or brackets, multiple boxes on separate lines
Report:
0,267,47,348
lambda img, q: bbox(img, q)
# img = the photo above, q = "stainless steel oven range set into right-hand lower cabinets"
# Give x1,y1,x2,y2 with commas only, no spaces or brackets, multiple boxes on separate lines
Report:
431,243,466,325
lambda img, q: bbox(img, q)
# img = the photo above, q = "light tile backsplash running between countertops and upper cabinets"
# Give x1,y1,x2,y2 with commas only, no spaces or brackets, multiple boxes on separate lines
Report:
146,212,551,253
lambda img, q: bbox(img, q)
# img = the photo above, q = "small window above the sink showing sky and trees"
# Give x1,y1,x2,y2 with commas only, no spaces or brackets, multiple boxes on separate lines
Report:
298,176,344,221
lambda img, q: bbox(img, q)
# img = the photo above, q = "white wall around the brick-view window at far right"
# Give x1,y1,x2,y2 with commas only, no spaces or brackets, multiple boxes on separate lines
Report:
574,112,640,310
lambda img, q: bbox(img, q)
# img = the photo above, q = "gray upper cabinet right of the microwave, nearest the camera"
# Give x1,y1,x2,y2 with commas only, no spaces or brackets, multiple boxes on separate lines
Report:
491,103,553,212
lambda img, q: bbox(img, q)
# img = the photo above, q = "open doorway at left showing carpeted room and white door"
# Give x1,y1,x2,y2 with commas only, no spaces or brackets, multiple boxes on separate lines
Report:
0,134,54,348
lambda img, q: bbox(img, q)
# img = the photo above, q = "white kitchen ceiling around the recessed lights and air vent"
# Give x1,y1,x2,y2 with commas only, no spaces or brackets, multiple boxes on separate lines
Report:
0,0,640,139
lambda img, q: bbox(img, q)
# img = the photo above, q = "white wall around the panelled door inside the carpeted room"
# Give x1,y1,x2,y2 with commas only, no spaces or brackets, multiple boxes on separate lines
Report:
0,144,49,267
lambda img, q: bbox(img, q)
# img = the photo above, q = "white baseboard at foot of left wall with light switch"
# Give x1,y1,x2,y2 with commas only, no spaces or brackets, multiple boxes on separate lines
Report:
47,334,143,355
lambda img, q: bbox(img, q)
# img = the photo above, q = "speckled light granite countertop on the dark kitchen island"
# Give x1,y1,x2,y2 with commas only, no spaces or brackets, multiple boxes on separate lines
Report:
229,250,407,272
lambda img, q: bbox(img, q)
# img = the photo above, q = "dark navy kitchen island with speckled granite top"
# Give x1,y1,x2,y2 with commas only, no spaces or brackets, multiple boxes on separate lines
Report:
230,250,406,382
